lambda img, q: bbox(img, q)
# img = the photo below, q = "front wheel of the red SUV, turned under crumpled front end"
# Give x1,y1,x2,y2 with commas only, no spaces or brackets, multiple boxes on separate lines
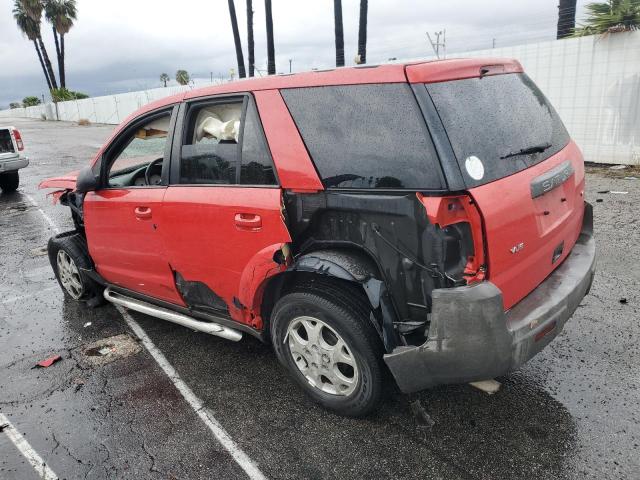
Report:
47,232,103,306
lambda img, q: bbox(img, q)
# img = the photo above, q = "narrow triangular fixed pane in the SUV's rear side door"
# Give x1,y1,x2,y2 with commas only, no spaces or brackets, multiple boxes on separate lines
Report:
240,102,278,185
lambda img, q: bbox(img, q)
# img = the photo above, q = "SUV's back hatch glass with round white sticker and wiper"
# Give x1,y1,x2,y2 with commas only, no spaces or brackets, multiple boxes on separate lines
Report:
426,74,569,187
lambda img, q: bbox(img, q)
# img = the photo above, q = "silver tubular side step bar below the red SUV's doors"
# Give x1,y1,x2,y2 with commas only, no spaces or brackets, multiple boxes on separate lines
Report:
104,287,242,342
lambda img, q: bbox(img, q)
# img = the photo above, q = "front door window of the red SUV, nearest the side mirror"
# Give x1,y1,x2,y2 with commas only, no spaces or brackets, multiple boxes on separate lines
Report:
107,112,171,187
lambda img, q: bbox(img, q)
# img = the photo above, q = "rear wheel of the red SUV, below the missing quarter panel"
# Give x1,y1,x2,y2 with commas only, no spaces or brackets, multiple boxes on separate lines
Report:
271,284,383,417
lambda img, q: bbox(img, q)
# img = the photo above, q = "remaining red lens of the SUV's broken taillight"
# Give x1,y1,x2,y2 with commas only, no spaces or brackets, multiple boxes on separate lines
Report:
417,193,486,283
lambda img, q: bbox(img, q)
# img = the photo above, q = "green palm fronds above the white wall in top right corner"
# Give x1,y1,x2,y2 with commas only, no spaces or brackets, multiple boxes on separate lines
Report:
574,0,640,37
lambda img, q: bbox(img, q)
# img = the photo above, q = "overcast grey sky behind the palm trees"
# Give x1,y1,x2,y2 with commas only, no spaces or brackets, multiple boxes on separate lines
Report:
0,0,587,108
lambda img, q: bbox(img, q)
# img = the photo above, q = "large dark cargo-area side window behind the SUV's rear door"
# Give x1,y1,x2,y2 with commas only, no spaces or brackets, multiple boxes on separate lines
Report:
282,84,443,189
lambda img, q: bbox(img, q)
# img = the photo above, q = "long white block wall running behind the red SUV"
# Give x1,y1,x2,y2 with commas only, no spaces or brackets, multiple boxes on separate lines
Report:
0,32,640,164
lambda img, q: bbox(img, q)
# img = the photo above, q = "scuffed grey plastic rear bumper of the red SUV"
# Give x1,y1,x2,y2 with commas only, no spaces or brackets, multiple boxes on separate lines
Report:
384,203,596,392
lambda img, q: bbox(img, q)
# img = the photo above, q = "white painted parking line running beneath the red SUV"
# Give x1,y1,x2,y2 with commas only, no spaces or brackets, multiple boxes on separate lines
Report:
26,193,266,480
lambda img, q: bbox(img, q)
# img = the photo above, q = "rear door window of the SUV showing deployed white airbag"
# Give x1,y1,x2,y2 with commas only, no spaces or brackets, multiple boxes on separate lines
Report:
180,100,243,185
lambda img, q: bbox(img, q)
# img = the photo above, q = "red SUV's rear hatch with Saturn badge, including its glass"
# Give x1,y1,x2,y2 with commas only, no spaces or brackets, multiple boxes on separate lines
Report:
426,72,584,309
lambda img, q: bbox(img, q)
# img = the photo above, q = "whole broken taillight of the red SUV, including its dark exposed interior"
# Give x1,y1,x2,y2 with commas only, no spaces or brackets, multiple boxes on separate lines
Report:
417,193,486,283
